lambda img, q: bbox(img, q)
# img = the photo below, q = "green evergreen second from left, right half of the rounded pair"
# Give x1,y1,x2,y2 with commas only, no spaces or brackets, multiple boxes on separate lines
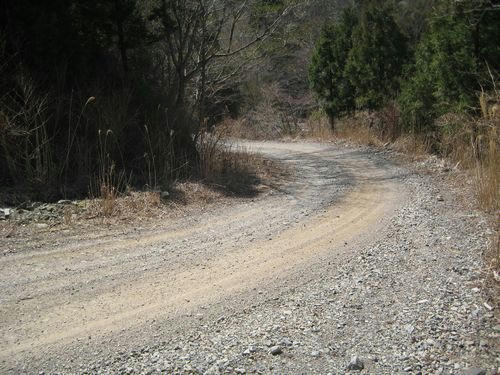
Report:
345,2,407,109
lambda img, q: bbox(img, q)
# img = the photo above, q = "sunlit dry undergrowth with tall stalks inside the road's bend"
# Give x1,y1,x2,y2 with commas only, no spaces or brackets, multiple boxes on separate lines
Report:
84,128,282,219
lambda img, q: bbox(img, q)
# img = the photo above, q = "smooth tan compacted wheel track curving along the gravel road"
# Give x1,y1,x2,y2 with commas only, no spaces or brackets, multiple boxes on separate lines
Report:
0,144,405,374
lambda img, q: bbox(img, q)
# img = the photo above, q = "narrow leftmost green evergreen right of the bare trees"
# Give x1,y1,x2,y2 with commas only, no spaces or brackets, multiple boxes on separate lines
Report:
309,8,358,118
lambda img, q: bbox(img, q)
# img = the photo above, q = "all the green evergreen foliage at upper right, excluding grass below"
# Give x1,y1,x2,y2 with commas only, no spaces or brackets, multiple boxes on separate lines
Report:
309,0,500,135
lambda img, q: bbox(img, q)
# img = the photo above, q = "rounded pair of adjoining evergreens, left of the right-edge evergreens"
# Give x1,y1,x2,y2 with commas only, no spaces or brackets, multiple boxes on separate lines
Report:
309,3,407,122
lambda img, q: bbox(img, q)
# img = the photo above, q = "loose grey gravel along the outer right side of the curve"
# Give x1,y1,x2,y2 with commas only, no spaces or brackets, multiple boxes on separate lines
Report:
1,144,500,374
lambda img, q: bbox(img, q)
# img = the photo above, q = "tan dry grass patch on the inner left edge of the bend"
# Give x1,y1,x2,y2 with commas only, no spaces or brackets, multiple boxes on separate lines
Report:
53,128,287,226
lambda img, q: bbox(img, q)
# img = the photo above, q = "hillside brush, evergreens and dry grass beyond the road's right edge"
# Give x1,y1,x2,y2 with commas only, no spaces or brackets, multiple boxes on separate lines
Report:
224,0,500,276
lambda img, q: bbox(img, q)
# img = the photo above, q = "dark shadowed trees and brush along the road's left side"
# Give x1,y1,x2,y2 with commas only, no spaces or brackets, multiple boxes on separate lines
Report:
0,0,288,209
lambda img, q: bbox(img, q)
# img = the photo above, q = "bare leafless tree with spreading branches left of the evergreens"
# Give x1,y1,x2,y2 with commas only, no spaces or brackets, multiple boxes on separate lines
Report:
156,0,289,132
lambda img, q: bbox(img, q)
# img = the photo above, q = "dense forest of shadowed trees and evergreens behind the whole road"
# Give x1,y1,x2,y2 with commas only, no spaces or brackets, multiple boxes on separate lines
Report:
0,0,500,206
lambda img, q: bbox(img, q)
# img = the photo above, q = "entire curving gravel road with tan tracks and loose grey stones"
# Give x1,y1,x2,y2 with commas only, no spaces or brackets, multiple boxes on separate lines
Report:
0,142,500,374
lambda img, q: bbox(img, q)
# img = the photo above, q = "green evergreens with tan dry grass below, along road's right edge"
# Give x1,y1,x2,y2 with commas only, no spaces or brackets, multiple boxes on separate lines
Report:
309,0,500,281
